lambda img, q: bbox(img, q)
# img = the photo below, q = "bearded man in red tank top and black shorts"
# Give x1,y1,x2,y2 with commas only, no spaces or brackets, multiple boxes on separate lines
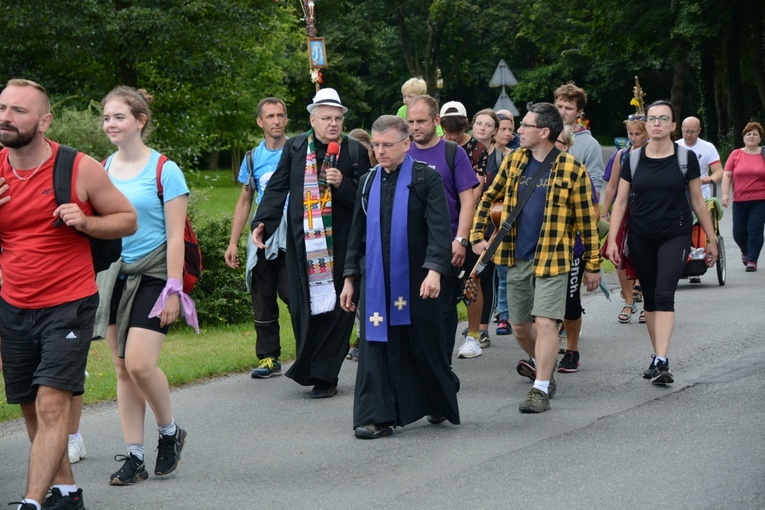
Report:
0,79,137,510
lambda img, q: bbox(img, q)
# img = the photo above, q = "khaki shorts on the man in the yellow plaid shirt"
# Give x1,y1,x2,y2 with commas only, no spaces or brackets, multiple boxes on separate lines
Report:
507,259,568,324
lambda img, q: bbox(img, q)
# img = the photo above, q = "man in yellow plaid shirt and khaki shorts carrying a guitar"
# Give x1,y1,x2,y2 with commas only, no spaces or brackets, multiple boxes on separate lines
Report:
470,103,600,413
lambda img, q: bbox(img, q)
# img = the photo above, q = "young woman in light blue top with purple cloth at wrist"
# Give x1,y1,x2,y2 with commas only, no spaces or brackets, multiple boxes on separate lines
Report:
99,86,189,485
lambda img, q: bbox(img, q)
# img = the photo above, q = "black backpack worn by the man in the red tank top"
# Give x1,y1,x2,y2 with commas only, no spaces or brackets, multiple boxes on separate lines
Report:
53,145,122,273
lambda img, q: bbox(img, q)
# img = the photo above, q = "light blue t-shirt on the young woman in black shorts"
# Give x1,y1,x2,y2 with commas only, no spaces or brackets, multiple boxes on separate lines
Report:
105,149,189,264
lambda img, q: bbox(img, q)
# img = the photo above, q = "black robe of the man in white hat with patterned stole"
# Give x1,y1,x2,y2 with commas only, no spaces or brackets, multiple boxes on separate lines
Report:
252,136,371,386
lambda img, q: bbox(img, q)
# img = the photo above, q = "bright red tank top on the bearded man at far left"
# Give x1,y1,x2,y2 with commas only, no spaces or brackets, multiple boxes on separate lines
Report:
0,141,98,309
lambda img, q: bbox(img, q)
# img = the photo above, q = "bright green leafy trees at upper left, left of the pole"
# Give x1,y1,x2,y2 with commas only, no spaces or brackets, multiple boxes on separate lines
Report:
0,0,312,168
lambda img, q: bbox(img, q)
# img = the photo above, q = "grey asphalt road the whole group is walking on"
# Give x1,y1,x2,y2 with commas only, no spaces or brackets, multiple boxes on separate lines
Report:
0,173,765,510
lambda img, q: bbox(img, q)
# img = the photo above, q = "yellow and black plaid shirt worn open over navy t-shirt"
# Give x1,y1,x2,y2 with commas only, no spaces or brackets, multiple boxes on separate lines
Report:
470,149,601,276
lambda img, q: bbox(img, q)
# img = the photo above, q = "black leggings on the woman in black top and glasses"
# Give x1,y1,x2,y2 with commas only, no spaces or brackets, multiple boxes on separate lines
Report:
627,232,691,312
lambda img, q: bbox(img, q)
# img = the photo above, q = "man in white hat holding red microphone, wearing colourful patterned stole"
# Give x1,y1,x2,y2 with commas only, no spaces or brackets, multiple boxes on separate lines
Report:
252,88,371,398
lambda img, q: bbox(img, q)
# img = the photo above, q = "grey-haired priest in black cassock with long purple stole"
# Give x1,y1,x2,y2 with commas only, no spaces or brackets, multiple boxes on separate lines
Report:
340,115,460,439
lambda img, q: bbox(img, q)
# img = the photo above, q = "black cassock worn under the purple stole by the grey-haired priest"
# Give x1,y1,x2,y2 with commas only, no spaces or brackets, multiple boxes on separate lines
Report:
345,163,460,428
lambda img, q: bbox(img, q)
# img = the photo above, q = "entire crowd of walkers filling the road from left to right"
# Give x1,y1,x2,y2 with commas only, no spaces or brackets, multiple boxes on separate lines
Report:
0,78,765,510
